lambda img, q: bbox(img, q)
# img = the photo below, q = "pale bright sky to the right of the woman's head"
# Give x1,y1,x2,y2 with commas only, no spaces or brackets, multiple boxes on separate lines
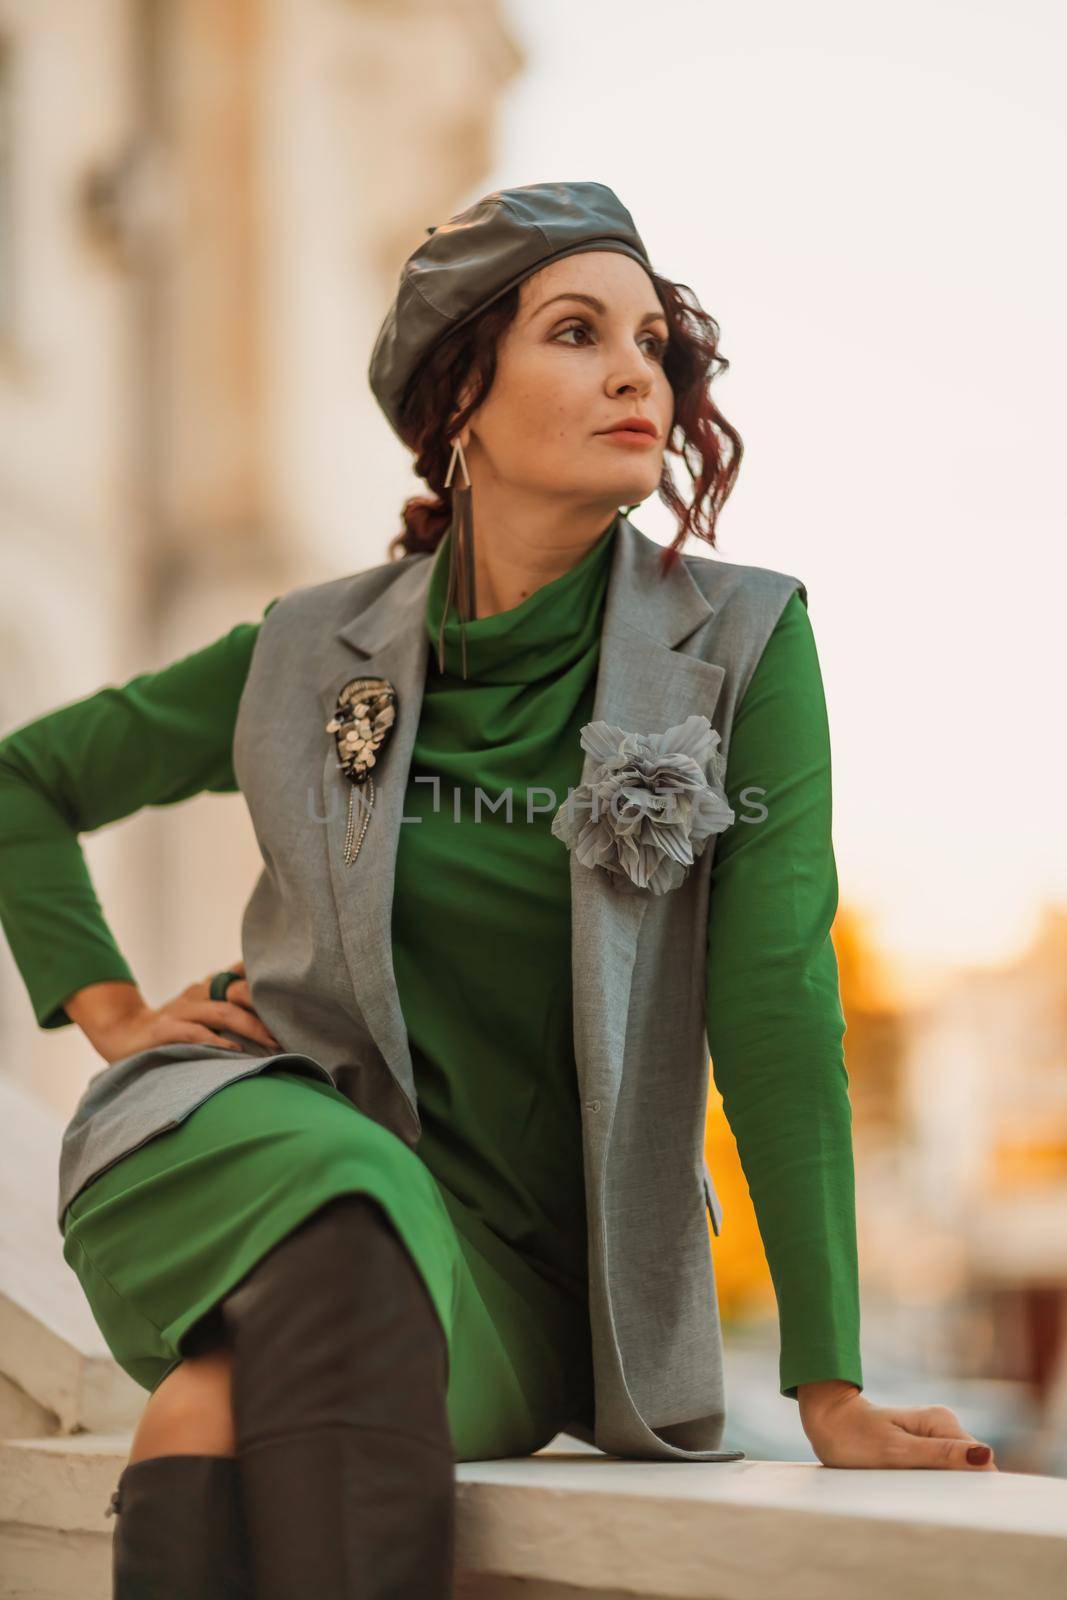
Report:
456,0,1067,974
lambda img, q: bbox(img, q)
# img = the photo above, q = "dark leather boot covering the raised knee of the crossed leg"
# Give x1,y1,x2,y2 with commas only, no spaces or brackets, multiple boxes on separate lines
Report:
222,1194,454,1600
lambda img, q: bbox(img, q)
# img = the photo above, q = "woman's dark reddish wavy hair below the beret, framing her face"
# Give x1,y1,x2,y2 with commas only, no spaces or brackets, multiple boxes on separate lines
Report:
389,272,744,573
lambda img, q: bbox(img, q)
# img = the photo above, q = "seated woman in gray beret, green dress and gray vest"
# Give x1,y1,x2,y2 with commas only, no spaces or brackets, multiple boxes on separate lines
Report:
0,182,995,1595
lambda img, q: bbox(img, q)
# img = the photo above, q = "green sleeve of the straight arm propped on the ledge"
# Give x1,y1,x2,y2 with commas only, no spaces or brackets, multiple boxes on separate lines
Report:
707,590,862,1400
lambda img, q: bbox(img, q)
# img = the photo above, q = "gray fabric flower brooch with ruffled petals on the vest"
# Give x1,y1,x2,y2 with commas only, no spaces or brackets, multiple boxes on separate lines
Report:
552,715,734,894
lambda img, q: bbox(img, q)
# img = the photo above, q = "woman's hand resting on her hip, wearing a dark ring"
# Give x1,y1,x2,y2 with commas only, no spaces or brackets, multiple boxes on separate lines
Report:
64,962,282,1066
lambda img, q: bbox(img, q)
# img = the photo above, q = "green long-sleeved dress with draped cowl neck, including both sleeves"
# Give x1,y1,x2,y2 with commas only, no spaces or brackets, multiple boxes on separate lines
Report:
0,523,862,1414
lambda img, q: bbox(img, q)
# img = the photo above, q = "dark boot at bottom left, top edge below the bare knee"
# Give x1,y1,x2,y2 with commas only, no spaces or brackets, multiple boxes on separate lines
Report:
107,1456,253,1600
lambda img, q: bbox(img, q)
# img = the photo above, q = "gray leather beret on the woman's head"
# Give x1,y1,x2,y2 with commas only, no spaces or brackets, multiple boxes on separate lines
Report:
368,182,651,437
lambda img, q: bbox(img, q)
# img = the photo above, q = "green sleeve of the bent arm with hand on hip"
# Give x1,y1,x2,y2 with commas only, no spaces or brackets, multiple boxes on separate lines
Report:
0,597,280,1027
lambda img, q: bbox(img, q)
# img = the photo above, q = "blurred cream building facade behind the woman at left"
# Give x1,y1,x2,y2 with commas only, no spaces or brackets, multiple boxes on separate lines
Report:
0,0,522,1112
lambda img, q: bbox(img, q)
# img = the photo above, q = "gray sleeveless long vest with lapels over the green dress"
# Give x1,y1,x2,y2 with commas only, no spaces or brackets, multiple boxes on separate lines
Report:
58,517,806,1461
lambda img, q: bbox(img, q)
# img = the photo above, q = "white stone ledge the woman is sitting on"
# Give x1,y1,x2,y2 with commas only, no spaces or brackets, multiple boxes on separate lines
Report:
0,1434,1067,1600
